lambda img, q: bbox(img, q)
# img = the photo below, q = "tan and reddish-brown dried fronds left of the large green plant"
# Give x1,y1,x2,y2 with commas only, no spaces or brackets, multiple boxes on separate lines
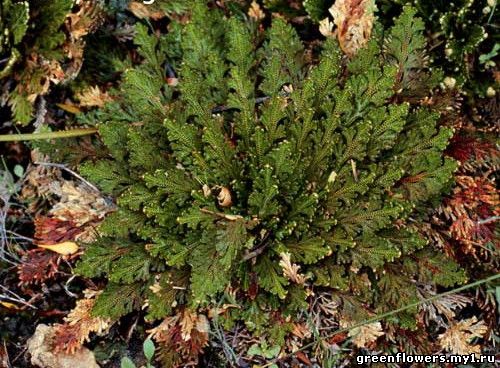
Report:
17,165,112,285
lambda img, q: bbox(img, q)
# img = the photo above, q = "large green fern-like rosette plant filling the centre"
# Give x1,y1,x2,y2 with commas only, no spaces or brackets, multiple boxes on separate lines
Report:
71,2,463,348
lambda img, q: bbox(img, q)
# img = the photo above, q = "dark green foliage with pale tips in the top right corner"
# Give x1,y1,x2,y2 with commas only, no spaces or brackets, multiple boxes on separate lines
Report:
378,0,499,97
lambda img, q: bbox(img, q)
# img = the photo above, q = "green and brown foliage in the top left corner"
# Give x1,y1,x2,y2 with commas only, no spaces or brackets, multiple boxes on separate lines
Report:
0,0,73,124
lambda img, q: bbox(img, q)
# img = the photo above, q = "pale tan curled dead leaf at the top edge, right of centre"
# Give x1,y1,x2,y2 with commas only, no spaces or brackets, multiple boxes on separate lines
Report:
320,0,375,57
